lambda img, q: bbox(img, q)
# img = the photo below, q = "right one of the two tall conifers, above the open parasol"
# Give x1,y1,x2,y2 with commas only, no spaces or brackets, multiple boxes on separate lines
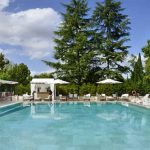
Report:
92,0,130,78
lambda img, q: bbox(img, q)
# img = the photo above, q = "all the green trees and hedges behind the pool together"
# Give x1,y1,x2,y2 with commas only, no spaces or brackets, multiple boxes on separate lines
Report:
0,0,150,95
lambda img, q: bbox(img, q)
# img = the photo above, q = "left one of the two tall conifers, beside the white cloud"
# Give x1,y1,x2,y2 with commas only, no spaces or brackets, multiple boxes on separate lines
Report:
45,0,94,92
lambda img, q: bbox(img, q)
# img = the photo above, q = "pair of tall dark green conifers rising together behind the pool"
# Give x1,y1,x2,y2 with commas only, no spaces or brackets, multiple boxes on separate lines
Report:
44,0,130,85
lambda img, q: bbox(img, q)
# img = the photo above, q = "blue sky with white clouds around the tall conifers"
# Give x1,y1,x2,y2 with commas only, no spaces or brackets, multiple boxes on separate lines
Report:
0,0,150,73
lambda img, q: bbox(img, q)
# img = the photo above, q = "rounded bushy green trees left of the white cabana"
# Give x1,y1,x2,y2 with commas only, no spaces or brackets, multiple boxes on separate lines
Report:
0,54,31,95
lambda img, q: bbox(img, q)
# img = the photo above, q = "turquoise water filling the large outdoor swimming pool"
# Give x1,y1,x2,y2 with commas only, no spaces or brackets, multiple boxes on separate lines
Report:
0,103,150,150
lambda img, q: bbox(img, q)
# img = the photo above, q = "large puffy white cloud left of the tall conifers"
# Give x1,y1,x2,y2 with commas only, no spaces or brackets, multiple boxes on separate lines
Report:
0,0,61,59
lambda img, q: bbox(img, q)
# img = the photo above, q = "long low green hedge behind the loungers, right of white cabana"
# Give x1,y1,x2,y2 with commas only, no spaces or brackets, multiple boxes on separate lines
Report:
57,80,150,96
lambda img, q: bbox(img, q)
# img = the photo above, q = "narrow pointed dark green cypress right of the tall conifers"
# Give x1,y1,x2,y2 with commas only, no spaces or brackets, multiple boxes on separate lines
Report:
131,53,144,84
